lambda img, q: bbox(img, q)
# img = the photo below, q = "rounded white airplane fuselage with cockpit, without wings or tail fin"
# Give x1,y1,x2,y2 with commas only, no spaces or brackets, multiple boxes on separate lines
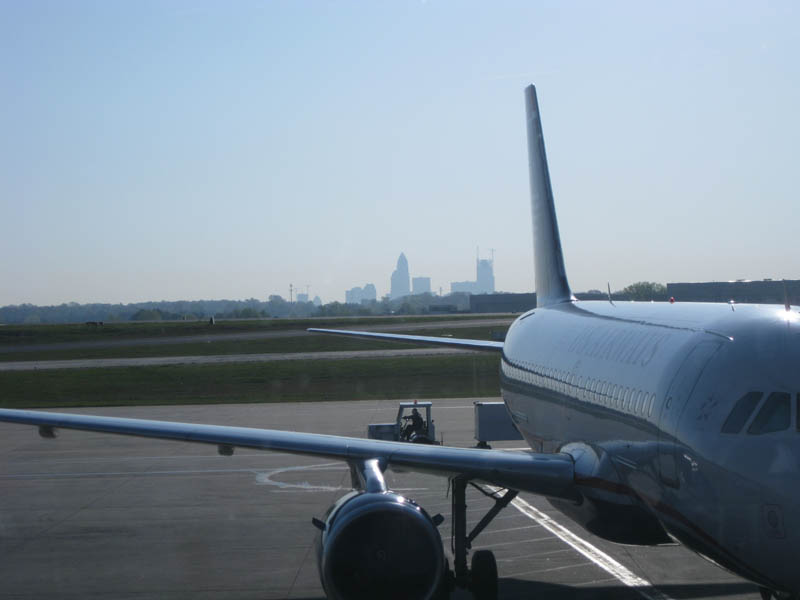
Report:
501,302,800,592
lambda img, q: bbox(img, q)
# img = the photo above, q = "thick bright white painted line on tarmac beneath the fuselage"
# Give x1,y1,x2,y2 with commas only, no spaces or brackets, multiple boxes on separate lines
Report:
497,488,672,600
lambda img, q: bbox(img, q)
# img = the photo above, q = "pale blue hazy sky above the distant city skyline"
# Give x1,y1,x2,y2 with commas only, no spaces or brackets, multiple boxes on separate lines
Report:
0,0,800,305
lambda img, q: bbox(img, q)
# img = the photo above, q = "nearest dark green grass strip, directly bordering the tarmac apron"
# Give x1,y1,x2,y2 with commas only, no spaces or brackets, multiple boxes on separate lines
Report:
0,354,500,408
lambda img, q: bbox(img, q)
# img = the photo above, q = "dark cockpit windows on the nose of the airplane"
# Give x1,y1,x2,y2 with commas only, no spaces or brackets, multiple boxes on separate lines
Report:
722,392,800,435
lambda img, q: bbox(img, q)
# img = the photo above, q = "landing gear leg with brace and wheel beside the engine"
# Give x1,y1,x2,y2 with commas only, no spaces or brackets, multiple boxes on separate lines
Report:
452,477,519,600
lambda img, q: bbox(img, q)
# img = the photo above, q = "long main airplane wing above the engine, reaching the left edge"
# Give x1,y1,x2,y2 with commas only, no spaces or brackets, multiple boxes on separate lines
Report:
0,409,578,500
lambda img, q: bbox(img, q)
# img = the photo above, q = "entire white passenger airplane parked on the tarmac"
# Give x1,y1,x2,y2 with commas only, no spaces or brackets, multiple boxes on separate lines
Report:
0,85,800,600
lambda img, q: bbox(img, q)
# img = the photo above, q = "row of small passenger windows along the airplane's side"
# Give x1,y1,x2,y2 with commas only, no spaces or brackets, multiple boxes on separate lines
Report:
503,363,656,417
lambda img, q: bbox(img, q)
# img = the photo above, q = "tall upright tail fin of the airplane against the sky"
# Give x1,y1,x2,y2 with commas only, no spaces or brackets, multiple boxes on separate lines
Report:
525,85,575,307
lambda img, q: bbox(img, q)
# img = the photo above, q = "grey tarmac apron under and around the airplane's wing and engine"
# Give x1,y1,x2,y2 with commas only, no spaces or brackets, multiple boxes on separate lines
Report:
0,399,759,600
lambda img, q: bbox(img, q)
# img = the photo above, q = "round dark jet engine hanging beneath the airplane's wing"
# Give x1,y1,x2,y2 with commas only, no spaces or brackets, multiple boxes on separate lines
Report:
317,491,445,600
